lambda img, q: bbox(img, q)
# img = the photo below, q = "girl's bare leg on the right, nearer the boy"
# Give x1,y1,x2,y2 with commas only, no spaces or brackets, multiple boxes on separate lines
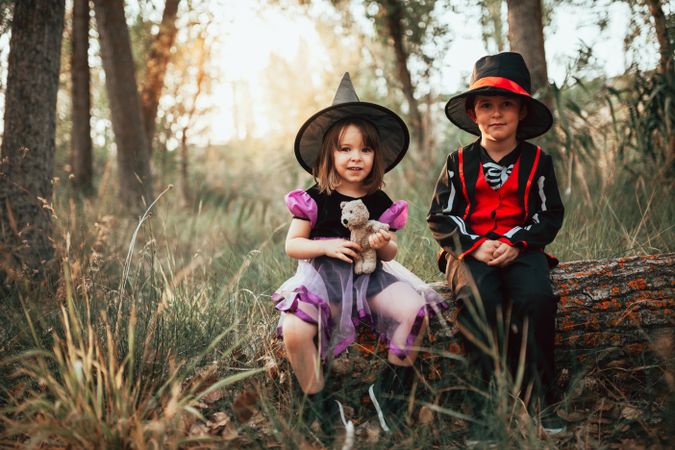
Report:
370,283,427,366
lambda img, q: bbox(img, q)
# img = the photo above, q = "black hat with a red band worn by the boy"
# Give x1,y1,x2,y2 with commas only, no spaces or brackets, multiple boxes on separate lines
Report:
445,52,553,139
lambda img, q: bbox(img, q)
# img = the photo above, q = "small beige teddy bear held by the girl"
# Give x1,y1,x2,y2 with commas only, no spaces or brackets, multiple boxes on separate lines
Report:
340,200,389,275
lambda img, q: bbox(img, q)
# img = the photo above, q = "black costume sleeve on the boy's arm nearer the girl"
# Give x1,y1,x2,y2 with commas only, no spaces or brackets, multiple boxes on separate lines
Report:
427,152,486,258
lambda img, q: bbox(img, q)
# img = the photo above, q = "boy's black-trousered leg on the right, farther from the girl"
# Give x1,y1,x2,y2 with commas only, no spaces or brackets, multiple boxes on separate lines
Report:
504,251,557,406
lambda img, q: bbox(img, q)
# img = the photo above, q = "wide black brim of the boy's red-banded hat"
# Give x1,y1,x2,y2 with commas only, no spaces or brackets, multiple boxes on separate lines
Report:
445,86,553,140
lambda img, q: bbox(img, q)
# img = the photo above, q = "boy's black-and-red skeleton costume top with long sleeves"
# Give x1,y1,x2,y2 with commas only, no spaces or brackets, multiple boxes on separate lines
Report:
427,141,564,267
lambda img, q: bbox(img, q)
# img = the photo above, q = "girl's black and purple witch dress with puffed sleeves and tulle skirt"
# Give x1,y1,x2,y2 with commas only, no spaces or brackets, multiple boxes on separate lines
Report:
272,185,447,360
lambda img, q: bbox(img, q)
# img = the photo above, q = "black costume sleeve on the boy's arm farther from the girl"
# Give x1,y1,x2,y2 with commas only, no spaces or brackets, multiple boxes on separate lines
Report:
505,153,565,248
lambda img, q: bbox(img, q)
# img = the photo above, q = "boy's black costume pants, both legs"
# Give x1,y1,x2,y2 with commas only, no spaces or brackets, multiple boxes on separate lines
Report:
446,250,557,405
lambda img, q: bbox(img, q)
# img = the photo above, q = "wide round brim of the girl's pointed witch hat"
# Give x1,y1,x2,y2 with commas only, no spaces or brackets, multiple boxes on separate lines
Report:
295,101,410,174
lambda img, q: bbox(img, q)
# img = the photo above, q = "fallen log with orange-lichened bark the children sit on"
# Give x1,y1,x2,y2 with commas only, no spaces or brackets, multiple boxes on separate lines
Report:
277,253,675,418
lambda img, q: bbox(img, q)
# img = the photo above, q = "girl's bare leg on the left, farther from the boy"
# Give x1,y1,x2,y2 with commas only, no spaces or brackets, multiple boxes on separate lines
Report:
282,314,324,394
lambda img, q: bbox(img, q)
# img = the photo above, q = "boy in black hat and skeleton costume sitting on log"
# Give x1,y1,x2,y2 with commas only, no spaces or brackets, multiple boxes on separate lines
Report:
427,52,564,432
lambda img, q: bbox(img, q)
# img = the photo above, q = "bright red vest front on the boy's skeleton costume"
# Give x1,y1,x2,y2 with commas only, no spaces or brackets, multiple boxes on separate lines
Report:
467,158,525,236
